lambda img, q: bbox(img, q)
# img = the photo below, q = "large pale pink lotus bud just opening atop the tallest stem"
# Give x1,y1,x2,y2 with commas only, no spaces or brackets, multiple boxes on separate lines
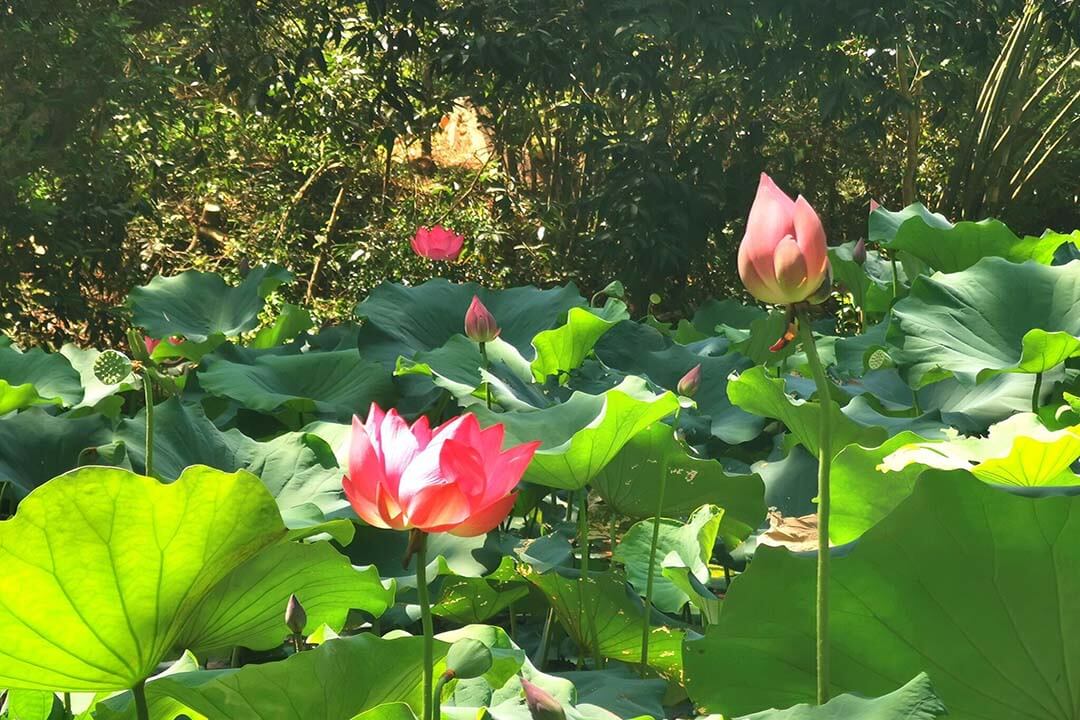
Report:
739,173,828,304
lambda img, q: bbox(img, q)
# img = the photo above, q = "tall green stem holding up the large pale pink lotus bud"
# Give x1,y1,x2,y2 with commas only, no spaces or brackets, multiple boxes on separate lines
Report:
798,310,833,705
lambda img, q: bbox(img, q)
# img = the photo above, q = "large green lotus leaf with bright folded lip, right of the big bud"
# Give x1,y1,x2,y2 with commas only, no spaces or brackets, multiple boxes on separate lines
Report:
890,257,1080,388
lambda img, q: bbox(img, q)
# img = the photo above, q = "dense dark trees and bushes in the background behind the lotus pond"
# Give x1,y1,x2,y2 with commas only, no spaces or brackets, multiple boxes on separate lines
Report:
0,0,1080,347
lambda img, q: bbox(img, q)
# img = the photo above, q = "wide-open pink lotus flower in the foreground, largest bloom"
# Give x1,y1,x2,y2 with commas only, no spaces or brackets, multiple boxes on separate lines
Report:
342,404,540,538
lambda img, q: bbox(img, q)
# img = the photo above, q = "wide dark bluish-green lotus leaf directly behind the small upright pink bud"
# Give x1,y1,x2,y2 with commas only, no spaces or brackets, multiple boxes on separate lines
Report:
356,277,585,368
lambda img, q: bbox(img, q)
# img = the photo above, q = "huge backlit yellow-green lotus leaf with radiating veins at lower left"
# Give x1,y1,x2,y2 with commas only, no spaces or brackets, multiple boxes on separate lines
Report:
0,466,389,691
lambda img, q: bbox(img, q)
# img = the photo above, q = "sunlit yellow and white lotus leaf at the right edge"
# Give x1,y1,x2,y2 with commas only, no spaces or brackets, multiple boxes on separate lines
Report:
880,412,1080,487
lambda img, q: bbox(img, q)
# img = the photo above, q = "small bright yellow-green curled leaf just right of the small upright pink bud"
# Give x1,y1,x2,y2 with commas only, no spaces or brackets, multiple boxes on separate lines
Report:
532,300,630,382
